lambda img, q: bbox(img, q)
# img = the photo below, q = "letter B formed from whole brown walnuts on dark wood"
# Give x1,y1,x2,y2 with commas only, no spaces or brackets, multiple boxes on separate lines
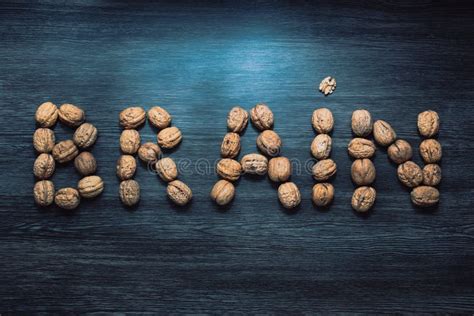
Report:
33,102,104,210
